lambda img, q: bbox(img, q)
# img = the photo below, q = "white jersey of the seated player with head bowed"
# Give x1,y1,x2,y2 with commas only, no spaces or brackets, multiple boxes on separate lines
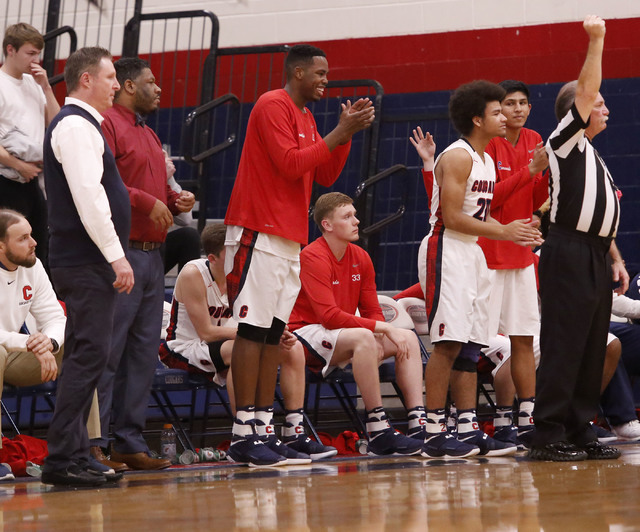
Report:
167,259,235,349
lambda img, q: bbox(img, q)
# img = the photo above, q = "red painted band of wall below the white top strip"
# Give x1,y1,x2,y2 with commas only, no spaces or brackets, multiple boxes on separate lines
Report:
57,18,640,108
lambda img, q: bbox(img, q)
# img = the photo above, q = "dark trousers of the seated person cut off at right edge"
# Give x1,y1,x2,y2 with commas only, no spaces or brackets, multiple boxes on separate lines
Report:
600,322,640,425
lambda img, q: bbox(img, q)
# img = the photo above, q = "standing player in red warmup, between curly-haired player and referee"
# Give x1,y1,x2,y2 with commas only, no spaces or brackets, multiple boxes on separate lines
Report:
478,80,549,447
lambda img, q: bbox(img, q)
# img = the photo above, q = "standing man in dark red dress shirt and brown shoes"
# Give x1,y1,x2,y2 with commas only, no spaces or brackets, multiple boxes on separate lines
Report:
91,58,195,469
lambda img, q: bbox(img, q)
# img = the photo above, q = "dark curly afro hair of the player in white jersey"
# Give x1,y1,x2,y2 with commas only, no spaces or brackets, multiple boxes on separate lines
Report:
449,79,505,135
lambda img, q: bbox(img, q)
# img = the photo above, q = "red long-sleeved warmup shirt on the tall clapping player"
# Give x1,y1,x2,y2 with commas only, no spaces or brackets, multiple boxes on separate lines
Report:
224,89,351,244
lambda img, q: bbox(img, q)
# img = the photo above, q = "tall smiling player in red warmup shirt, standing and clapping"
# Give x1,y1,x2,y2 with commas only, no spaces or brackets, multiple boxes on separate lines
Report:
225,45,374,466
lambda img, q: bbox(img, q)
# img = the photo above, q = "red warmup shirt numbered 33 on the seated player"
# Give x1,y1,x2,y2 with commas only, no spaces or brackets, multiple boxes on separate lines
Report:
289,237,384,331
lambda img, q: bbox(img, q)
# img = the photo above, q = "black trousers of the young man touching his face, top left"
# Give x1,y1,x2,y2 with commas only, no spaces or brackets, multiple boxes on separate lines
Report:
0,176,49,268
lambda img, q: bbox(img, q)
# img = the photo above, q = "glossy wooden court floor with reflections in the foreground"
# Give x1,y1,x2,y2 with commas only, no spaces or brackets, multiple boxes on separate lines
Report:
0,445,640,532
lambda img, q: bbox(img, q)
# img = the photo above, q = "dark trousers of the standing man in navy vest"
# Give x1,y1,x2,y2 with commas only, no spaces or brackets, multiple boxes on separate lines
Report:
44,262,116,471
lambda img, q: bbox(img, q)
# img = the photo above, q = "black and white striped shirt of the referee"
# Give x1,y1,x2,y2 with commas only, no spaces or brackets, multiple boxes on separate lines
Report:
546,104,620,238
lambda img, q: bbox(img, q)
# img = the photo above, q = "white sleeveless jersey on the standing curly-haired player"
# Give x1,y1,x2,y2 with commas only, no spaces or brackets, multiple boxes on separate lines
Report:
429,139,496,240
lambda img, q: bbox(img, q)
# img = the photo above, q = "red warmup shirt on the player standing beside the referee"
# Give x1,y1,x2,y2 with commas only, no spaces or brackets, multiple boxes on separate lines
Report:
478,128,549,270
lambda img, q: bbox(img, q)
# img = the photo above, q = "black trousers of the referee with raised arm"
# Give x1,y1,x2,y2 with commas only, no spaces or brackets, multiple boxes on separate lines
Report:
533,225,612,446
